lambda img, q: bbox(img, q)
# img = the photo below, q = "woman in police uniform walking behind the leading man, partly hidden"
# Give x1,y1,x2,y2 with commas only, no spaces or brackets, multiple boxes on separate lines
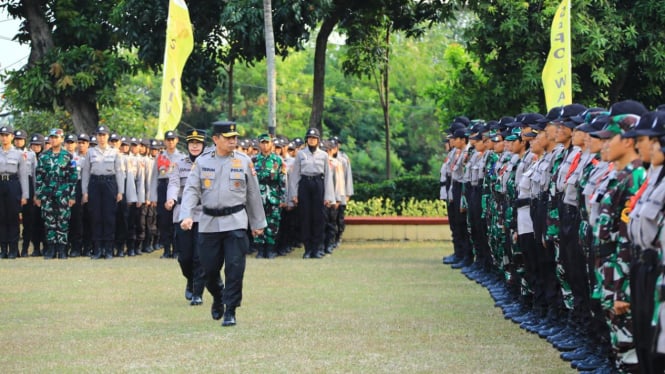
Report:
165,130,206,306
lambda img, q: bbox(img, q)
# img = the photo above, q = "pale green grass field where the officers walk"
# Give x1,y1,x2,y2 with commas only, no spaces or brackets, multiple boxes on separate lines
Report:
0,242,573,373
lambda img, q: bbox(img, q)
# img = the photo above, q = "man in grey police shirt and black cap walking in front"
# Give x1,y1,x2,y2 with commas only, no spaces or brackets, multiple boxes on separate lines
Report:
180,122,267,326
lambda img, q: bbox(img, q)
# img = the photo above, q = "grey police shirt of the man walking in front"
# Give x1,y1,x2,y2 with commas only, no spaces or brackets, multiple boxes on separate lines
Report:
179,151,268,233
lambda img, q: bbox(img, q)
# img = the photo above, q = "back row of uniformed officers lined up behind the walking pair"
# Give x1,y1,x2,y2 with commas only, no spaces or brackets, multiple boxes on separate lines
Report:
0,126,353,259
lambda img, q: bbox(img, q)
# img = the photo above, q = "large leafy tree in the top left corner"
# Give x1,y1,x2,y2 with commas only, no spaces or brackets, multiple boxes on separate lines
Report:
0,0,130,132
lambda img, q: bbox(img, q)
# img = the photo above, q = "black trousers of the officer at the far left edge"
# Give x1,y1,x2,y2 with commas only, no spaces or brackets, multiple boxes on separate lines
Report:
0,177,21,245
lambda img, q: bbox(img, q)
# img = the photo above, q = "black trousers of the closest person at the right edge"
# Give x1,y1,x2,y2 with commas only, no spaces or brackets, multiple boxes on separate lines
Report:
630,249,665,373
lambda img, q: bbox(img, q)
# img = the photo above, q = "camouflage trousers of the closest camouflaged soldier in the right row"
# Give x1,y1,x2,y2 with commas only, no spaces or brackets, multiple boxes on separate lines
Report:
592,253,635,366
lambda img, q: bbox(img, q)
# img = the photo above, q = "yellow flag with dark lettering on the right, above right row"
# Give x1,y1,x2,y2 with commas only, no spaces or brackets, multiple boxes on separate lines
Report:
542,0,573,110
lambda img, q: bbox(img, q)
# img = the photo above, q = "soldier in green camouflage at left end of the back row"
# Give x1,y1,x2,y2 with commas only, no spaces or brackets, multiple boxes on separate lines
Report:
35,129,77,259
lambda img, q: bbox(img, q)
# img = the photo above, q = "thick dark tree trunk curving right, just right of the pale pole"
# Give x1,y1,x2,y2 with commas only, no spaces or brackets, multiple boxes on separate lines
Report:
309,14,339,133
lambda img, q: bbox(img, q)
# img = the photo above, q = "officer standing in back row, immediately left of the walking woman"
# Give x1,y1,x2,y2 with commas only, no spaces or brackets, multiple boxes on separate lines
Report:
150,131,184,258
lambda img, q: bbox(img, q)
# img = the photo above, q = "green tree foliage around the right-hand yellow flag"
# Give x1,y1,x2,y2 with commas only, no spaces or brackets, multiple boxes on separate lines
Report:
432,0,665,123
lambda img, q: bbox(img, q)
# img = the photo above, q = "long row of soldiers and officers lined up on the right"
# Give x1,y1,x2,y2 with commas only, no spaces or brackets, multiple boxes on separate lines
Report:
441,100,665,373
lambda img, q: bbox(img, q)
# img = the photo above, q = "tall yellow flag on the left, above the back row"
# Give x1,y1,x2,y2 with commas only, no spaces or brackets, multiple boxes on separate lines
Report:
156,0,194,139
